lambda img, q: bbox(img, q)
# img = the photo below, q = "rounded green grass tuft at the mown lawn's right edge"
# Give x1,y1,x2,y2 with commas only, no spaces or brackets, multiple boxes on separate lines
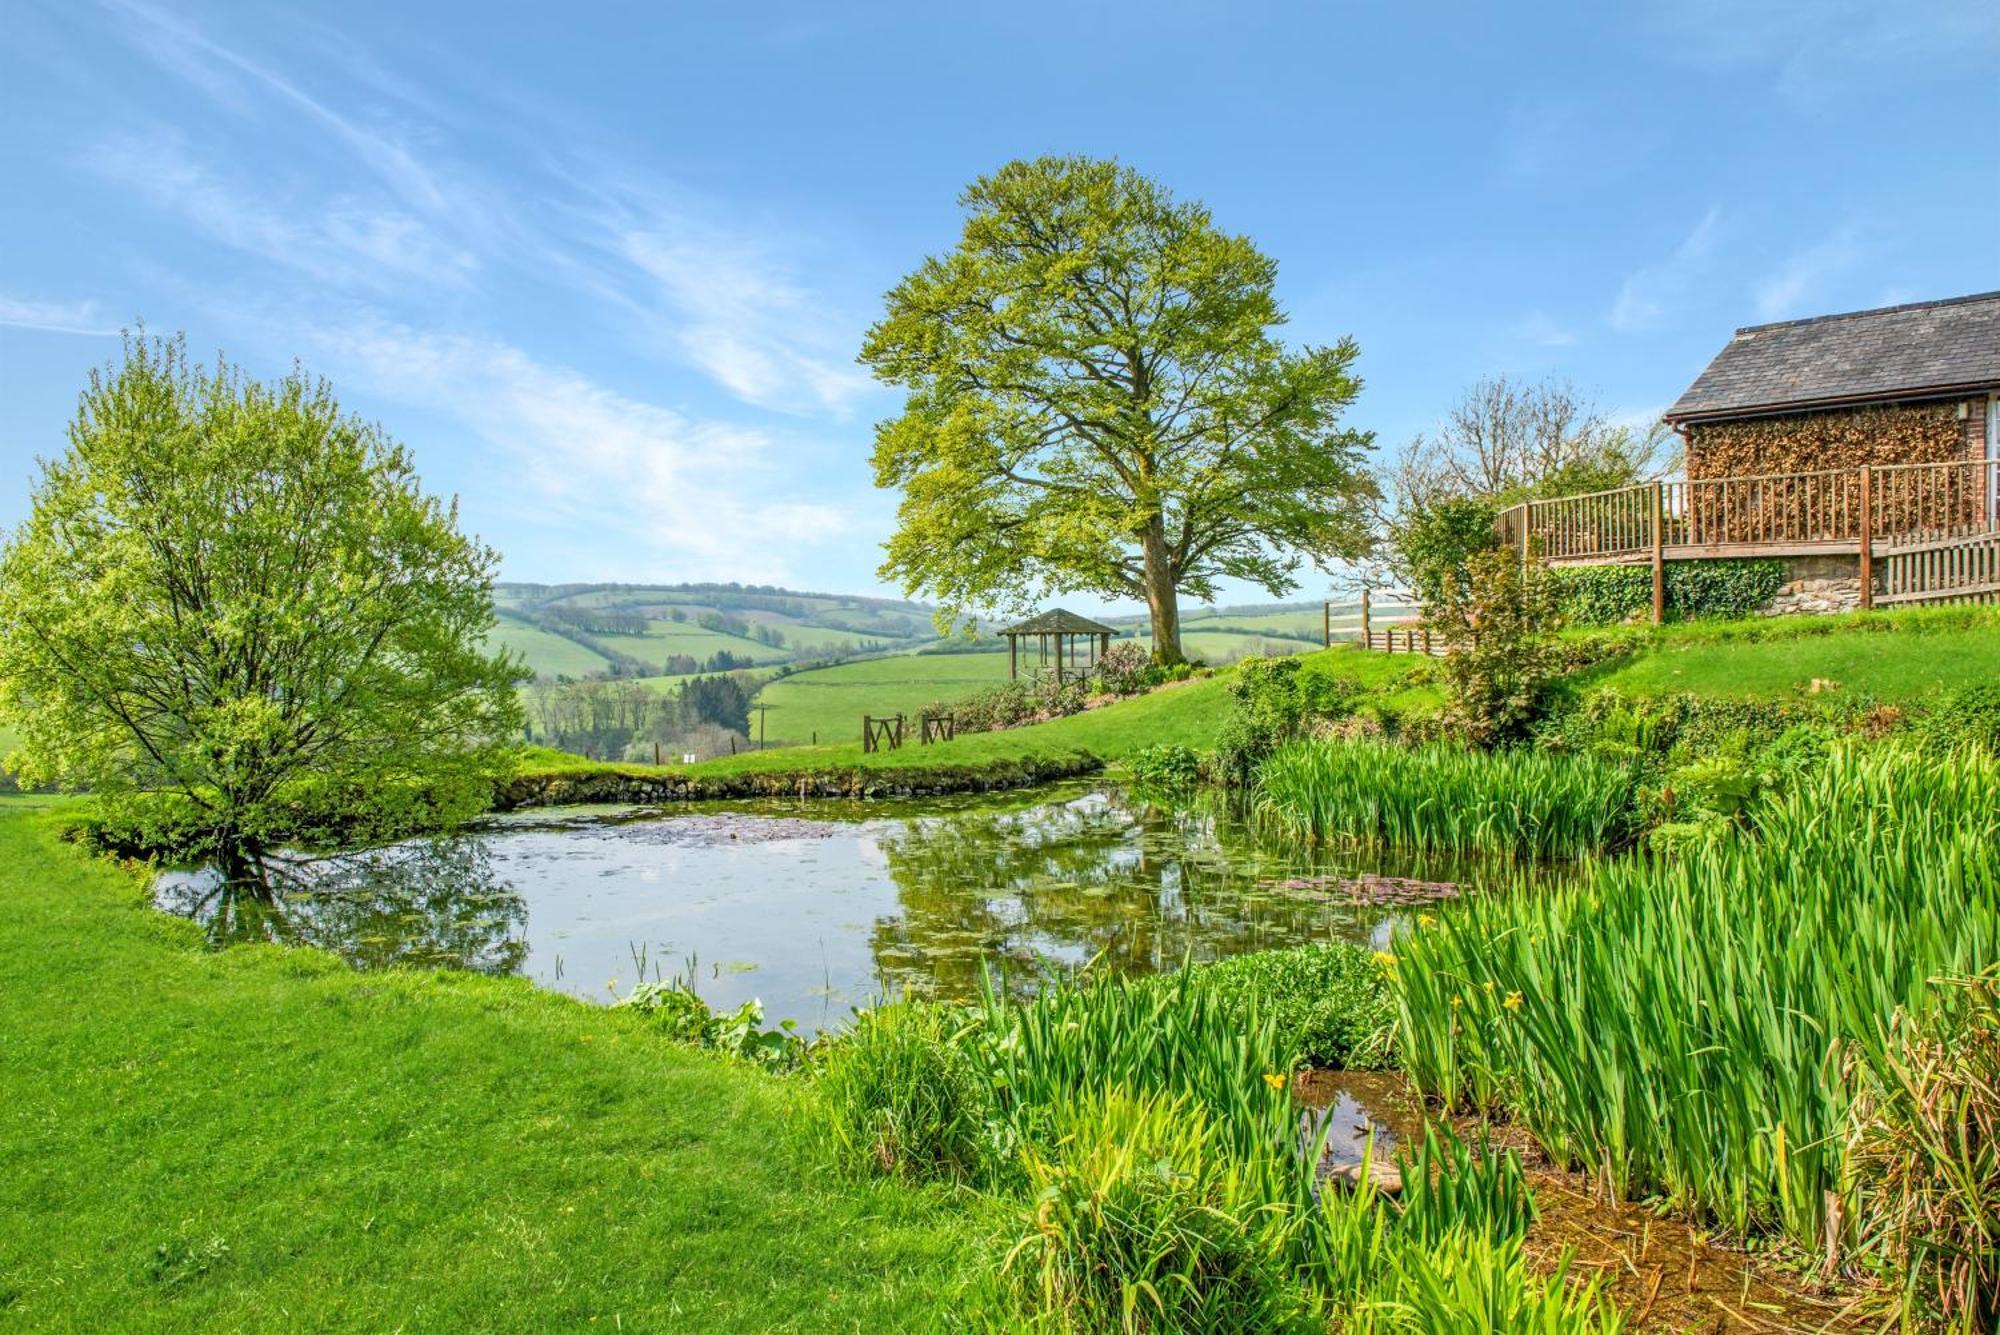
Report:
816,1001,994,1183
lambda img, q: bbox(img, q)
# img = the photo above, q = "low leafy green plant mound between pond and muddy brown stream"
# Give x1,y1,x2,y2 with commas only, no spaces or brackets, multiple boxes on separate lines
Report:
1196,941,1396,1071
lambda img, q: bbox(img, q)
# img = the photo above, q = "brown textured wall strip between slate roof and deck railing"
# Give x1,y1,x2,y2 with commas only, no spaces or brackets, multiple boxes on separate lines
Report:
1686,398,1986,478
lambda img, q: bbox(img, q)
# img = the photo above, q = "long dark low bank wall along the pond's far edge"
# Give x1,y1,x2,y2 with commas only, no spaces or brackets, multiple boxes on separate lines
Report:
494,751,1104,811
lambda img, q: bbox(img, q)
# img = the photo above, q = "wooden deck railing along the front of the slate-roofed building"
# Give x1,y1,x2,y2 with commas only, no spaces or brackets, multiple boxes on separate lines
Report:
1500,460,2000,620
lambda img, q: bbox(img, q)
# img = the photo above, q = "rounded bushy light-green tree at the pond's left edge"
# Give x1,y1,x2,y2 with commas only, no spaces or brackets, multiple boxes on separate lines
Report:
0,338,520,877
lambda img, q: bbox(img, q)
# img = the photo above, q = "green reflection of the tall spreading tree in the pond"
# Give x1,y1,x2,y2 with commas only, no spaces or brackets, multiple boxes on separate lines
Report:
870,793,1416,997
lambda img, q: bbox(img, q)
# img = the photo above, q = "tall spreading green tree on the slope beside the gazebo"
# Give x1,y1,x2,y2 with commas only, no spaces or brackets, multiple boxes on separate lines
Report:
862,158,1374,662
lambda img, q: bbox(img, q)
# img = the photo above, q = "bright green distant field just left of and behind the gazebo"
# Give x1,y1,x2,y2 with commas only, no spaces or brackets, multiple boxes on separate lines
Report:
758,654,1006,743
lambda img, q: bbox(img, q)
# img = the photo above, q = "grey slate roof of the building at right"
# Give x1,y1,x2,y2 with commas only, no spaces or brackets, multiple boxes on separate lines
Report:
1666,292,2000,422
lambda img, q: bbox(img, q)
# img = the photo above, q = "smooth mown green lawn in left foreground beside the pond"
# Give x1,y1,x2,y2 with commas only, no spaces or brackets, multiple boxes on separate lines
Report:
0,797,982,1331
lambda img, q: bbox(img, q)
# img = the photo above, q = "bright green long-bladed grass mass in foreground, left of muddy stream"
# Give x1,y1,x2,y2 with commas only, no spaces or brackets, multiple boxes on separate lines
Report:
814,967,1616,1333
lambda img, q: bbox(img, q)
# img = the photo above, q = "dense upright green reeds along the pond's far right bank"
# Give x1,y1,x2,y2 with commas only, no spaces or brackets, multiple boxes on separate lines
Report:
1256,741,1638,857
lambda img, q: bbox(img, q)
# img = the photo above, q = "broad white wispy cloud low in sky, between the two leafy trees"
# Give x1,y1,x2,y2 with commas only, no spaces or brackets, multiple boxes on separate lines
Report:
300,320,850,580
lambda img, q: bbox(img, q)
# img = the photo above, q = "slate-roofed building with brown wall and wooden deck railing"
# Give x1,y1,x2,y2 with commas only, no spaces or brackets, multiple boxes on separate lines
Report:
1502,292,2000,618
